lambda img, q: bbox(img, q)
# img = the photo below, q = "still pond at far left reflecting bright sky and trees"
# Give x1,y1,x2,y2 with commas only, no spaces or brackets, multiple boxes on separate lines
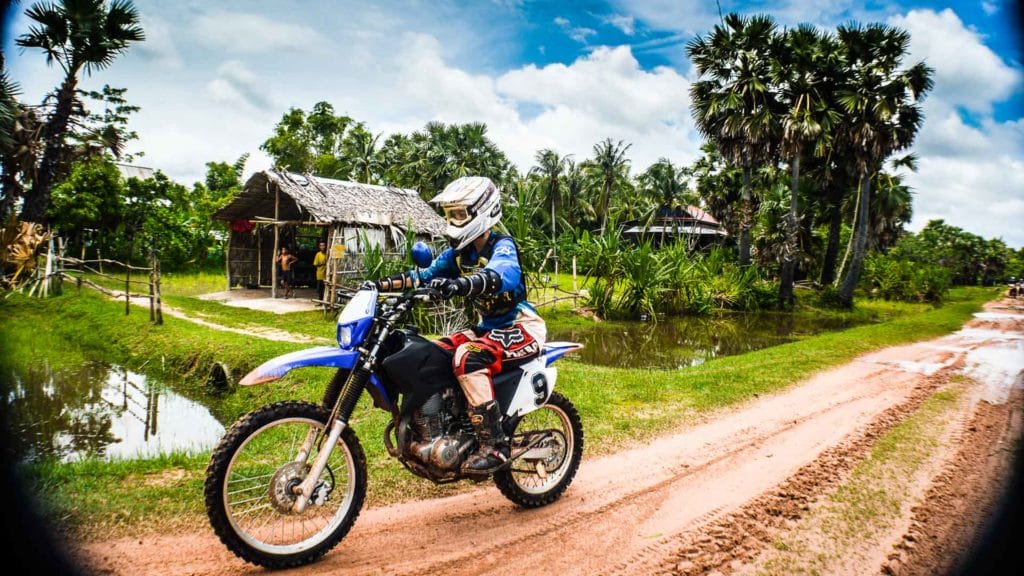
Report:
2,362,224,462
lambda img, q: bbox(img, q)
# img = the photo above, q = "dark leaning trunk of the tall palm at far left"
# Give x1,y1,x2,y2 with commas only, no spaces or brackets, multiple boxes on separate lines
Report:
22,75,78,223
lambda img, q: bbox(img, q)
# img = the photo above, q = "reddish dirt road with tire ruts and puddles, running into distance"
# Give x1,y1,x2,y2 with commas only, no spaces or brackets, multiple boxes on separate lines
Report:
84,300,1024,575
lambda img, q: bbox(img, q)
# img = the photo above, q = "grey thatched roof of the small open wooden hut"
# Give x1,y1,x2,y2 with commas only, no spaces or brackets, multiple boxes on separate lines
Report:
213,170,445,236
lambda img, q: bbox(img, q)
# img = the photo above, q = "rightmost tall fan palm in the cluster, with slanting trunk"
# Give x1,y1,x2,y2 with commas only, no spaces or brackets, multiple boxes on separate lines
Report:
838,24,933,306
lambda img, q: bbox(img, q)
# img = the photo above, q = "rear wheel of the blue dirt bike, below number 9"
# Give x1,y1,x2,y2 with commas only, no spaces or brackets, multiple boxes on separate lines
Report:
495,392,583,508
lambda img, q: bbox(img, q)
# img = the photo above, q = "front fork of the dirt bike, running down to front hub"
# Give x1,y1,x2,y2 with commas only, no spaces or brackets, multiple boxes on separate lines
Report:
292,362,370,513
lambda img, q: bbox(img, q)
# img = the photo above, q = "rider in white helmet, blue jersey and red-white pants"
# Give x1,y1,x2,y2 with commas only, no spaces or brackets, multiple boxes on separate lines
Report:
377,176,547,471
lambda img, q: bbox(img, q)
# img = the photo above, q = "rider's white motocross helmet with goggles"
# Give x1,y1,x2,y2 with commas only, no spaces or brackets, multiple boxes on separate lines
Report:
430,176,502,250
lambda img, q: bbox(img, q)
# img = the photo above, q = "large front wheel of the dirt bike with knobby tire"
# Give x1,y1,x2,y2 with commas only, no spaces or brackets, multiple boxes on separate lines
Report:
205,402,367,568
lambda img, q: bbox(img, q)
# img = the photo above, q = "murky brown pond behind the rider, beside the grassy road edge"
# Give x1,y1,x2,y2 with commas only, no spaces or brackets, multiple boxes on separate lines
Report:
548,313,858,370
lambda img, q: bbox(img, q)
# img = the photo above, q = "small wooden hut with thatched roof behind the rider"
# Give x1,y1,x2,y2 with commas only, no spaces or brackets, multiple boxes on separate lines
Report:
213,170,445,294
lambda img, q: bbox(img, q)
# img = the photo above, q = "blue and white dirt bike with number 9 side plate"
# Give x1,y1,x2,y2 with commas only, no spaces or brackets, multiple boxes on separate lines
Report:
205,245,584,568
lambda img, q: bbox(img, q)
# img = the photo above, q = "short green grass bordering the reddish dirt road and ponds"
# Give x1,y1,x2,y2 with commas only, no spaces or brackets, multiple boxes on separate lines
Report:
0,288,996,537
